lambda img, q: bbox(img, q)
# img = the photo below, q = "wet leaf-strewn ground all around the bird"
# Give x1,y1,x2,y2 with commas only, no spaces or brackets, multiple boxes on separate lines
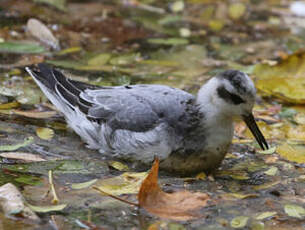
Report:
0,0,305,230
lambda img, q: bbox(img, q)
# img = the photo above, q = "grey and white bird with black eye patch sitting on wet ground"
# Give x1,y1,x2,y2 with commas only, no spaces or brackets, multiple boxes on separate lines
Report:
26,63,269,175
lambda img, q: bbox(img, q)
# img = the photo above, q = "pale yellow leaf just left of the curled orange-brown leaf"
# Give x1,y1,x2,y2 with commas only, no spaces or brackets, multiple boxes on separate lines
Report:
95,172,147,196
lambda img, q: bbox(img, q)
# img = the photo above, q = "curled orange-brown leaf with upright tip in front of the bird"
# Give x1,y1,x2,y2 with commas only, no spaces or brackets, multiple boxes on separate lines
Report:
138,159,210,221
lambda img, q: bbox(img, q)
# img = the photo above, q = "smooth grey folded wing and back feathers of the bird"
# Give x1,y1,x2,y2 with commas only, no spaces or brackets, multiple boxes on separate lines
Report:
80,85,194,132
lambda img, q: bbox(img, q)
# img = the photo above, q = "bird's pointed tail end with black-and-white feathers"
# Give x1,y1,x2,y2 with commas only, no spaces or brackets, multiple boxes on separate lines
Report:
26,64,99,149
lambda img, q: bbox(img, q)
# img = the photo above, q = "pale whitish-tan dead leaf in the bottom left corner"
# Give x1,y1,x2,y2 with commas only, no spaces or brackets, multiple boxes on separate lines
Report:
0,183,39,221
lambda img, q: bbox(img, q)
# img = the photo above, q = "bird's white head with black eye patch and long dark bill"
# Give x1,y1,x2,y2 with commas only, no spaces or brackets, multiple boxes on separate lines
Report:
197,70,268,149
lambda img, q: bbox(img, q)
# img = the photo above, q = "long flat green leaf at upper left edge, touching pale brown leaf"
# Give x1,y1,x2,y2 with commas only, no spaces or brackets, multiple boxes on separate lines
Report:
0,42,45,54
